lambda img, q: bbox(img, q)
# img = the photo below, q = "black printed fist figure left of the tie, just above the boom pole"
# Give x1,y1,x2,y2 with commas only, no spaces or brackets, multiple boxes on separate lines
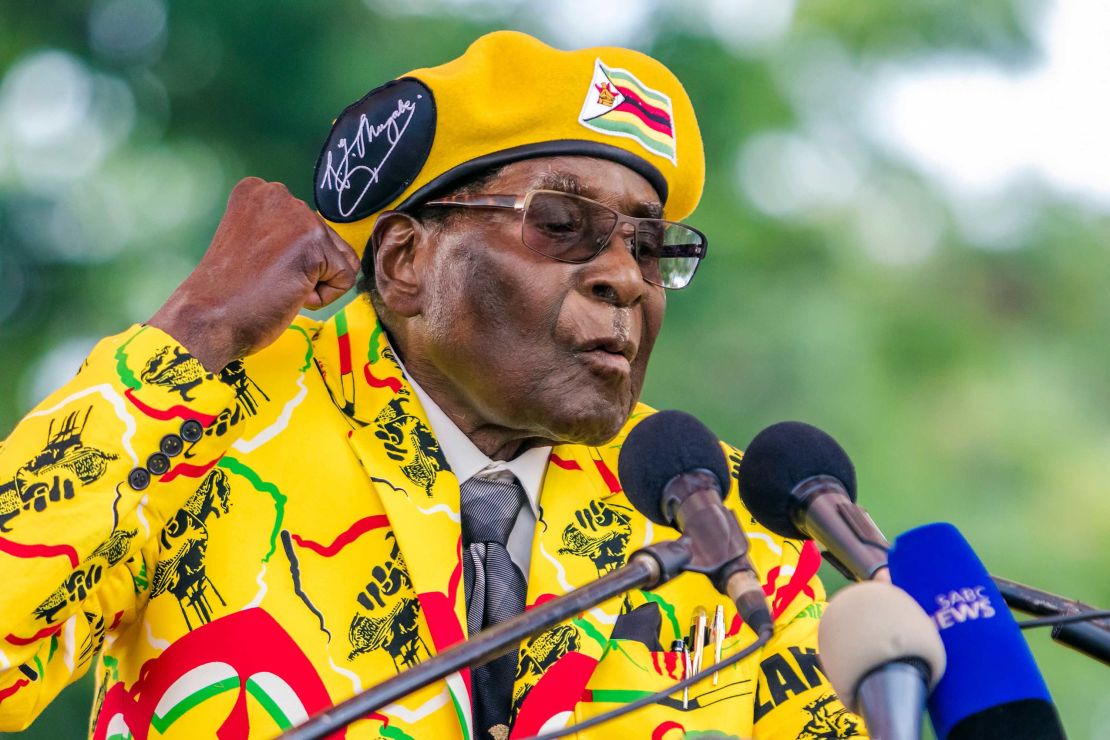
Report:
347,531,431,673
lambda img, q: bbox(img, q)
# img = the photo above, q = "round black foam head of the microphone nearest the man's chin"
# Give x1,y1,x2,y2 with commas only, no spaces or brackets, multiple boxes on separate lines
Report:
617,412,728,526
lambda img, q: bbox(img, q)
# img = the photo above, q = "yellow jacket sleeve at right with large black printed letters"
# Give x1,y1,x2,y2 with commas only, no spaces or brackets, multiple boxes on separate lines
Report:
754,533,867,740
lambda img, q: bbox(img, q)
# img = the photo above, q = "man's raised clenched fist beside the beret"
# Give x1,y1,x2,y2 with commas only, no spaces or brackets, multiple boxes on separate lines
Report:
148,178,360,373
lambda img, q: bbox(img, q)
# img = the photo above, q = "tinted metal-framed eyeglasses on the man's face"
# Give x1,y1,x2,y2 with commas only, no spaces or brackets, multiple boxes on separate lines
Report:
424,190,709,290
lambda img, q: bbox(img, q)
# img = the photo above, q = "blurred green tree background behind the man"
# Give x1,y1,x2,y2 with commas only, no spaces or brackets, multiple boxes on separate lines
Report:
0,0,1110,738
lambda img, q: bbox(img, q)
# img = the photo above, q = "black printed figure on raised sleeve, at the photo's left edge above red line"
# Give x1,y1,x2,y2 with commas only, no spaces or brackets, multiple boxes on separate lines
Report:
0,406,119,531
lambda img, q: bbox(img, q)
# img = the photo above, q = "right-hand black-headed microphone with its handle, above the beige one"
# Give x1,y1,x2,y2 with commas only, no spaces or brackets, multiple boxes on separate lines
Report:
739,422,889,580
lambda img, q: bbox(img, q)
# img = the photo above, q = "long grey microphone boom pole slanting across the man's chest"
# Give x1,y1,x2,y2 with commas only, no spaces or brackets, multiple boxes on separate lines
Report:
281,537,700,740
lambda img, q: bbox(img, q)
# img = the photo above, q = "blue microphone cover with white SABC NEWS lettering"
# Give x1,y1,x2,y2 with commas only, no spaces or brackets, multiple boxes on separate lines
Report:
890,524,1064,740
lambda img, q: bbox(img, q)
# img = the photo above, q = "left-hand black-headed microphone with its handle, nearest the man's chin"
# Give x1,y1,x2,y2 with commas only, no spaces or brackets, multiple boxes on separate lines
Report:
617,410,773,635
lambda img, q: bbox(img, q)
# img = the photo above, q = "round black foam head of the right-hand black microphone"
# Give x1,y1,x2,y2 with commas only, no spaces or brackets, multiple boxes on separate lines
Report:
739,422,856,539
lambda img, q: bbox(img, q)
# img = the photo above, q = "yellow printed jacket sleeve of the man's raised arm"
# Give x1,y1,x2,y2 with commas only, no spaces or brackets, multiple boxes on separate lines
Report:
0,326,239,730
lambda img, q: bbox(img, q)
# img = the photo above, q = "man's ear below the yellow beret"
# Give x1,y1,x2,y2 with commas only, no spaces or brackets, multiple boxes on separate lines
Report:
370,211,425,318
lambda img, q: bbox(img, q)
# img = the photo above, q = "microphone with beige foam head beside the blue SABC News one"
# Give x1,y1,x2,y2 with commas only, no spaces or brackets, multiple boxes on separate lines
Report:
817,581,945,740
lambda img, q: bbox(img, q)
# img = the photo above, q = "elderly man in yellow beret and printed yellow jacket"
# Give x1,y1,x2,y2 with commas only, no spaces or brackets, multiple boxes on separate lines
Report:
0,32,860,739
